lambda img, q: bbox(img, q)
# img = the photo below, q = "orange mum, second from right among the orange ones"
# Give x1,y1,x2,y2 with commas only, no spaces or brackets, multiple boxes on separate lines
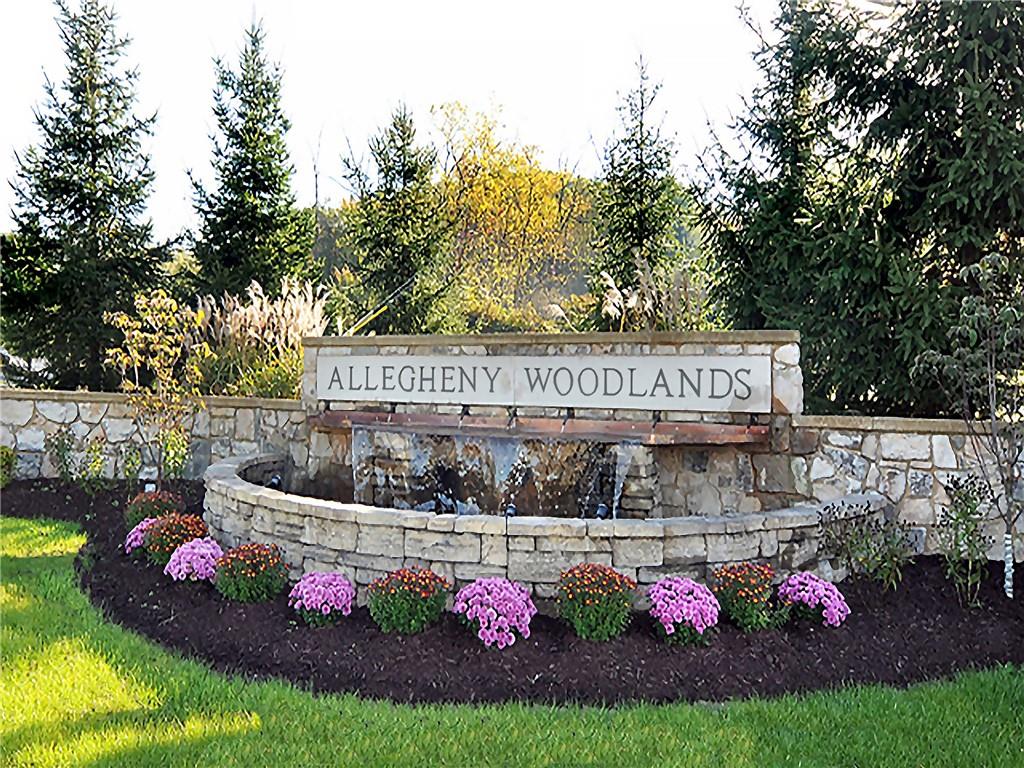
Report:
558,563,637,640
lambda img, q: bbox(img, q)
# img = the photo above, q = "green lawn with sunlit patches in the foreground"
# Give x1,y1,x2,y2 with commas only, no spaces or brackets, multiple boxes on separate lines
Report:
0,518,1024,768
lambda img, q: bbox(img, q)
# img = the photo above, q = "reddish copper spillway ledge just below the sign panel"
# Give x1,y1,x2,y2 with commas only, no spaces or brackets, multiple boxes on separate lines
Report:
310,411,768,445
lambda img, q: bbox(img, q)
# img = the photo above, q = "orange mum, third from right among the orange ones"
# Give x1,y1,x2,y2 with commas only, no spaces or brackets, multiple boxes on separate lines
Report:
370,567,451,635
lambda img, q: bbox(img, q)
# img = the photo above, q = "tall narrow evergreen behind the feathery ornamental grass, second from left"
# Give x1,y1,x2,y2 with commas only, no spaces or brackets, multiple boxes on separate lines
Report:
193,25,319,295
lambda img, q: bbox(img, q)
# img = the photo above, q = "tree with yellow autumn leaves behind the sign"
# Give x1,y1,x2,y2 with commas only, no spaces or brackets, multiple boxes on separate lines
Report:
435,103,592,330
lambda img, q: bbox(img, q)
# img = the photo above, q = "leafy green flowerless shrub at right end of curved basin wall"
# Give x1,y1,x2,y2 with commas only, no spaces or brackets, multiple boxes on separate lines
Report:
821,504,913,590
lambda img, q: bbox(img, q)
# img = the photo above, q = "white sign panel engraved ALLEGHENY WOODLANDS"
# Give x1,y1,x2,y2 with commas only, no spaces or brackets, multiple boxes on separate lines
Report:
316,350,771,413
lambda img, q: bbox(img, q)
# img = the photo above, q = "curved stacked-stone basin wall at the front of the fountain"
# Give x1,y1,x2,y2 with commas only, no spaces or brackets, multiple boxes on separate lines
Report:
205,455,888,598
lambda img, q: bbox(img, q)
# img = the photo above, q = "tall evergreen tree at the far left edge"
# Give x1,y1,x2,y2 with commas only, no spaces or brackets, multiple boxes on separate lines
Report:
2,0,160,389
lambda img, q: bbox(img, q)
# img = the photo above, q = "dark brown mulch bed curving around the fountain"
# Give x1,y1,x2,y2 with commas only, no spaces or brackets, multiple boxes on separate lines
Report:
0,480,1024,705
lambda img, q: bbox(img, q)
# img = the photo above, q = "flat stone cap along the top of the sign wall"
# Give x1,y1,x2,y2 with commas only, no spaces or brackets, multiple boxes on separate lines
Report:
302,331,800,347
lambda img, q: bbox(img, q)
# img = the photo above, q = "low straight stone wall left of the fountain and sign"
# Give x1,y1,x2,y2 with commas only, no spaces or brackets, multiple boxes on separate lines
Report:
0,388,309,478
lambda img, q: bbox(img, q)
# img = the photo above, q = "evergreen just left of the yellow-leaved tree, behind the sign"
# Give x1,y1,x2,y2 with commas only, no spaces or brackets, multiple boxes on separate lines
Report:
345,106,452,334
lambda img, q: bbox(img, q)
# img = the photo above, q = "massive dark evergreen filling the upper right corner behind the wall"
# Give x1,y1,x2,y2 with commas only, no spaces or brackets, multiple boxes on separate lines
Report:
698,0,1024,416
